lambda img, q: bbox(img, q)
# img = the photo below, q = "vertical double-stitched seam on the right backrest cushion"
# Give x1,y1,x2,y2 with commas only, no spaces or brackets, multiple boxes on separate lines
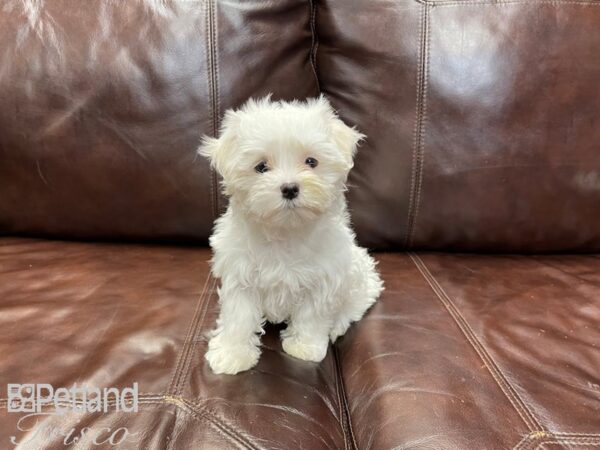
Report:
404,4,430,248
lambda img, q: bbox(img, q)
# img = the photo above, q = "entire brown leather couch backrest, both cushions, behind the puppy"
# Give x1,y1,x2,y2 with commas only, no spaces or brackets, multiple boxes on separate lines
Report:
0,0,600,253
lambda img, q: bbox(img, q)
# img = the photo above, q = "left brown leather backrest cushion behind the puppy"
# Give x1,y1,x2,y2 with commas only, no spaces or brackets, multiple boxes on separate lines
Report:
0,0,318,242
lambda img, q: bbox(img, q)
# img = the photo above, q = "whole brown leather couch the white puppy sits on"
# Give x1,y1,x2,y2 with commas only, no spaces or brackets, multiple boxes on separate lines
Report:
0,0,600,450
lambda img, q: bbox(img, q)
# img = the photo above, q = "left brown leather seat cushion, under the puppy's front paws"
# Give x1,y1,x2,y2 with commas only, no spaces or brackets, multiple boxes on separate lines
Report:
0,238,344,449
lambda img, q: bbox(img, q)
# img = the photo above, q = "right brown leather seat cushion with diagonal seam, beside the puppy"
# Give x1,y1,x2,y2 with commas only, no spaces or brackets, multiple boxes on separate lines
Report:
339,253,600,449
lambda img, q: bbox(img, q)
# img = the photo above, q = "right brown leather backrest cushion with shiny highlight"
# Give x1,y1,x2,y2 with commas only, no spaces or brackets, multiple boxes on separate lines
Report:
317,0,600,252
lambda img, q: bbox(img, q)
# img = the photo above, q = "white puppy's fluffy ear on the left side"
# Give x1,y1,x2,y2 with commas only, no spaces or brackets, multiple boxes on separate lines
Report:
198,110,240,178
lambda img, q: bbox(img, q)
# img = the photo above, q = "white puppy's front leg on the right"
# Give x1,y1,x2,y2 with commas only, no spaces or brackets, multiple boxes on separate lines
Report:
281,301,331,362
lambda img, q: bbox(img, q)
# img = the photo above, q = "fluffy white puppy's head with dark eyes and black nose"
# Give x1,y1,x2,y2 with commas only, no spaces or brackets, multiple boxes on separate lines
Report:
199,96,364,227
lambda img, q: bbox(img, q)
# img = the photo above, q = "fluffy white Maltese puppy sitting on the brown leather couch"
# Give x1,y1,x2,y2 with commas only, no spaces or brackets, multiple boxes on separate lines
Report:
199,96,383,374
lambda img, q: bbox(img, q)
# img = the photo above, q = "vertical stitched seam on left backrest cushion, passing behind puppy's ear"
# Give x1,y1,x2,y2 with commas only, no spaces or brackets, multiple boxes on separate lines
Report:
205,0,219,219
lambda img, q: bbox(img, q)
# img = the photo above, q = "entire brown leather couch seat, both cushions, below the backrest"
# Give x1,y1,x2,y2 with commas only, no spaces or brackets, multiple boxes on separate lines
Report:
0,238,600,449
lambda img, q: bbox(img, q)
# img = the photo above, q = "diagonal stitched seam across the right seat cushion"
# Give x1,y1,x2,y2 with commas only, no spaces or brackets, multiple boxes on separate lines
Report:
409,253,544,432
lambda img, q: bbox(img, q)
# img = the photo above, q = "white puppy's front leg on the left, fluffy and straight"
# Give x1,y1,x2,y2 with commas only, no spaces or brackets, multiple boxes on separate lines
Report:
205,281,263,375
